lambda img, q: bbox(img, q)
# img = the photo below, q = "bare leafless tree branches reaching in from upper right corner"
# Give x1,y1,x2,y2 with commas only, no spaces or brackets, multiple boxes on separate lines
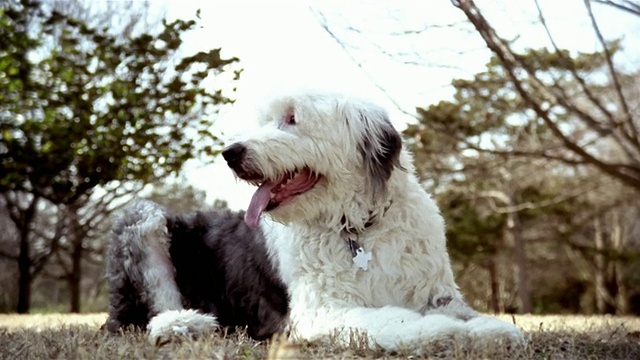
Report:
452,0,640,190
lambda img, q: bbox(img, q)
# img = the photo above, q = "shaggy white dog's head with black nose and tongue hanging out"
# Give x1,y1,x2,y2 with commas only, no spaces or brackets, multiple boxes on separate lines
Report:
222,92,402,227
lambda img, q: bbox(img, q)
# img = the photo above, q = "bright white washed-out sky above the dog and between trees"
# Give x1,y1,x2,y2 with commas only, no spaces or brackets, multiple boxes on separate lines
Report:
166,0,640,209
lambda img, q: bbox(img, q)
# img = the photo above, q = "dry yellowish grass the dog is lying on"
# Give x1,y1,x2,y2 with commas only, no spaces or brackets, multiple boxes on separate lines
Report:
0,314,640,360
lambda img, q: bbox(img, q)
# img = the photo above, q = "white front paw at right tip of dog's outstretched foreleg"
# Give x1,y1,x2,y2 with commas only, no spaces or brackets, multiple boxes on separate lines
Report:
466,316,526,346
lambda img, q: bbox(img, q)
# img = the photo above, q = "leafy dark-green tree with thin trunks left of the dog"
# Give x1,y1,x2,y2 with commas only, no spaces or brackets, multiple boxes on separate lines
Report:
0,0,239,312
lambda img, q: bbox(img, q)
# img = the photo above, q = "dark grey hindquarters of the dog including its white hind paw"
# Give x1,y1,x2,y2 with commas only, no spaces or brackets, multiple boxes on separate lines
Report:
105,199,288,344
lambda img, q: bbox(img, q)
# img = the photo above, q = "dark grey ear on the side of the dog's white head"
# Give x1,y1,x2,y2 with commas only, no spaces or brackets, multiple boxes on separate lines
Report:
358,111,402,199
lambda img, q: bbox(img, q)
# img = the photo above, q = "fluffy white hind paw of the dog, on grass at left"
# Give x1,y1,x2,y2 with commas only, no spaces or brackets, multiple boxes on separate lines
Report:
147,310,218,345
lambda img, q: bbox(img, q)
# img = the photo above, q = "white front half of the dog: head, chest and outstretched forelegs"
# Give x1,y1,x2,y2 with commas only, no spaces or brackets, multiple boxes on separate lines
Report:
222,90,524,350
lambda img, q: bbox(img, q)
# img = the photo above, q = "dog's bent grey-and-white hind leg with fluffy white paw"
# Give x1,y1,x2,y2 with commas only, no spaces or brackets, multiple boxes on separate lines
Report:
107,200,218,344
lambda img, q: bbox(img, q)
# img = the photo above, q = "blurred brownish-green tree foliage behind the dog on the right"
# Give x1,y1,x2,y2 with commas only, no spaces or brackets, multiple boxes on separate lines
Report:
404,42,638,312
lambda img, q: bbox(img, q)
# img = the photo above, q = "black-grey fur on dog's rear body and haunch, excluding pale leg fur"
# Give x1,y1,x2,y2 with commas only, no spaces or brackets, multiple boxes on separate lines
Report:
106,205,288,340
